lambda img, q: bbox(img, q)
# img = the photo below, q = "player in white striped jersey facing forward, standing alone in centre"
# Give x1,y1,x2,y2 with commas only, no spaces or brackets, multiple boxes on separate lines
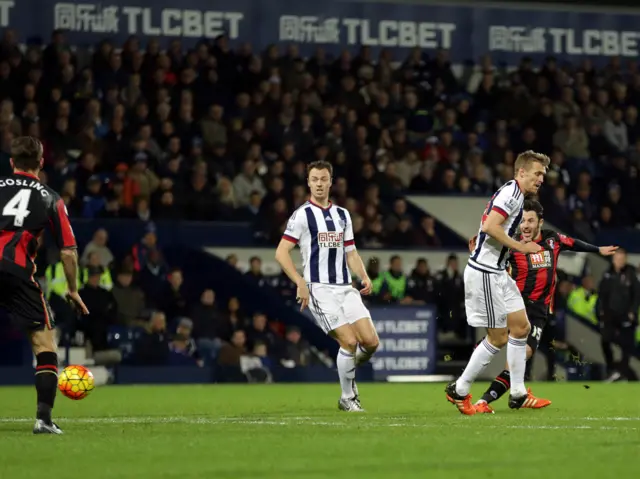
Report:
276,161,379,412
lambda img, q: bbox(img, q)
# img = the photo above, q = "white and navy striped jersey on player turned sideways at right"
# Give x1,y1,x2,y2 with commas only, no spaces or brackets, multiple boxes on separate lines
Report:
468,180,524,273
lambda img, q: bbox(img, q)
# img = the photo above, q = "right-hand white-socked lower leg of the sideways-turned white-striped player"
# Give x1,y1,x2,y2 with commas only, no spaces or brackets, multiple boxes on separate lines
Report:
507,309,531,409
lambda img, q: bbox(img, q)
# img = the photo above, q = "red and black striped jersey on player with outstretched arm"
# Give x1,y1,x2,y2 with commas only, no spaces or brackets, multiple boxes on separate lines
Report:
509,230,598,308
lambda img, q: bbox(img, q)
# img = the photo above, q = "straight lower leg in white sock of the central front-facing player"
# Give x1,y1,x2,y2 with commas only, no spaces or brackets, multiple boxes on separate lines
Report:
331,324,363,412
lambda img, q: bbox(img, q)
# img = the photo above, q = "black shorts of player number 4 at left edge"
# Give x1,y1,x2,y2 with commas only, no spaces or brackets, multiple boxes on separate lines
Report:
0,271,54,332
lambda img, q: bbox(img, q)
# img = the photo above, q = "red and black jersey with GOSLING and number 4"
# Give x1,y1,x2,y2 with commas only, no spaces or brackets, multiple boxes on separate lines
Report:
0,173,76,281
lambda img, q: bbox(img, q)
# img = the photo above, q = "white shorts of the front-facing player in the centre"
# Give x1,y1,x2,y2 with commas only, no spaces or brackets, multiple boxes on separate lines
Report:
308,283,371,334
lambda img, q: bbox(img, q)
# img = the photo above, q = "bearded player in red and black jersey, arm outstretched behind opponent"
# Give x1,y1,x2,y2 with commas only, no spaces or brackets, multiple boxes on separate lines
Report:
472,200,618,413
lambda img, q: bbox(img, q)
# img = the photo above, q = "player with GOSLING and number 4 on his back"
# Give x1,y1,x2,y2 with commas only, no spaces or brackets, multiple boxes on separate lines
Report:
0,137,89,434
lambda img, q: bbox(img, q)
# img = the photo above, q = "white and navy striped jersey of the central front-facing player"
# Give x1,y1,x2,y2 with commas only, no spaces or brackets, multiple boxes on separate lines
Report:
282,201,356,285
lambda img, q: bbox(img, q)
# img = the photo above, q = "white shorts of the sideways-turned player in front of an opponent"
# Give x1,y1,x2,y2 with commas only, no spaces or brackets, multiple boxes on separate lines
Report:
464,265,525,328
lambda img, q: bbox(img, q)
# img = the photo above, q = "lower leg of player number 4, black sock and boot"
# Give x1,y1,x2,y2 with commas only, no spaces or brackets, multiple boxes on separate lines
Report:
29,328,62,434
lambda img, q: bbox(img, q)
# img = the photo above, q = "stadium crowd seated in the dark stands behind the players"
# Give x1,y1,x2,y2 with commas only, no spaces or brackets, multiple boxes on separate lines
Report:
0,29,640,372
